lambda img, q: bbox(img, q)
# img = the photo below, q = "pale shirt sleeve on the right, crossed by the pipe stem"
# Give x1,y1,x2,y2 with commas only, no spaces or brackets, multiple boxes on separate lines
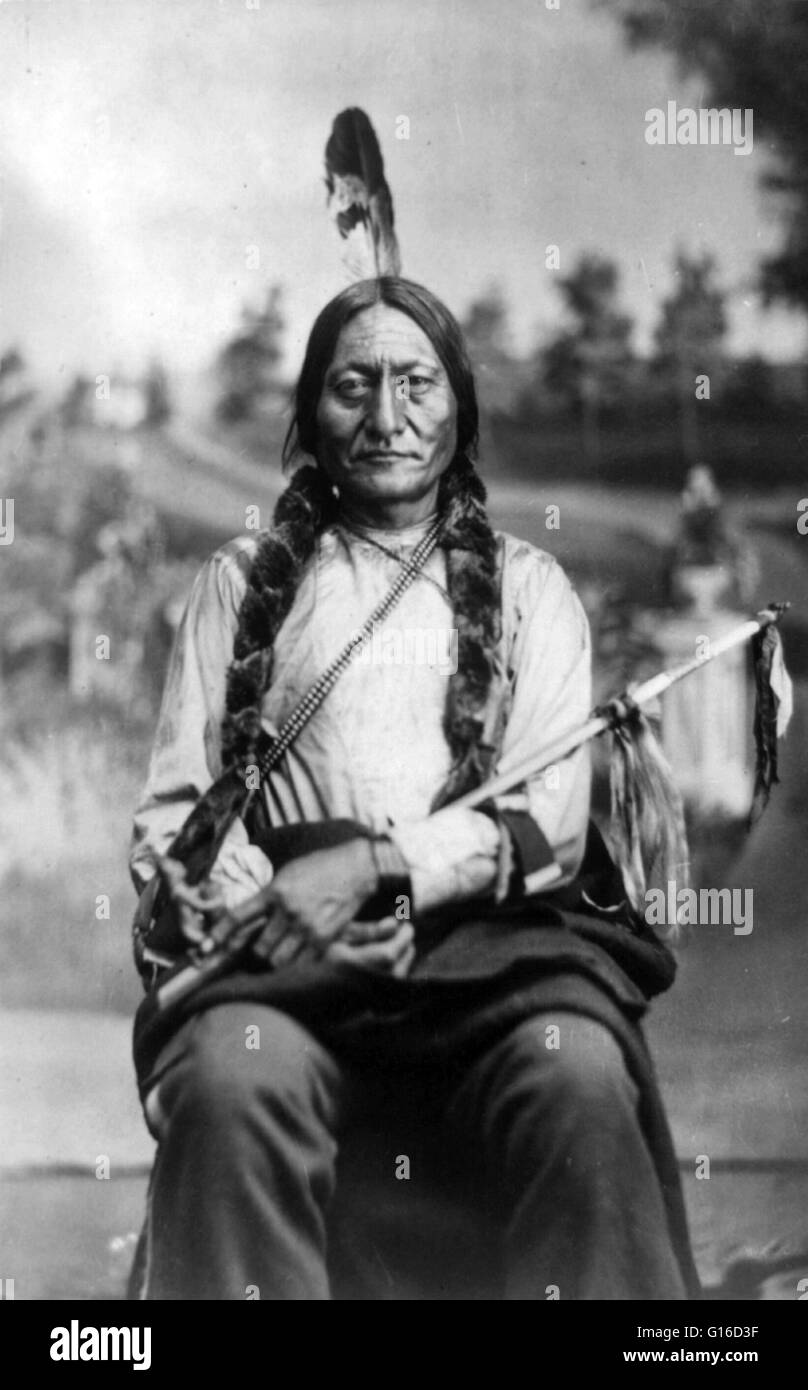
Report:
391,552,592,912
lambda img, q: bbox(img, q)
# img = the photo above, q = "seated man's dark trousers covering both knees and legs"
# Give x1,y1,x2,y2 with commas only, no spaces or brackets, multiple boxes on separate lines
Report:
138,1002,686,1300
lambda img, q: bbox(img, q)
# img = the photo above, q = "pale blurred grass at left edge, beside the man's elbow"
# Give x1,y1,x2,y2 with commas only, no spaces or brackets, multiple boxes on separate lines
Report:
0,689,147,1013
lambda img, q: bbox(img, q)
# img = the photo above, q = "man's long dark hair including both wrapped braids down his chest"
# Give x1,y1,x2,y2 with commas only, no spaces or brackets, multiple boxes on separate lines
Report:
146,277,501,917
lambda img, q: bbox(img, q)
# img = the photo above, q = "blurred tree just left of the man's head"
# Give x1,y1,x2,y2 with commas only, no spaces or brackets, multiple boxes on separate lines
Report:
217,285,285,423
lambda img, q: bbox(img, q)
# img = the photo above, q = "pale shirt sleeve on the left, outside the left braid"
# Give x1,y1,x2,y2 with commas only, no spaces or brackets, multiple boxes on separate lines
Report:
129,548,271,904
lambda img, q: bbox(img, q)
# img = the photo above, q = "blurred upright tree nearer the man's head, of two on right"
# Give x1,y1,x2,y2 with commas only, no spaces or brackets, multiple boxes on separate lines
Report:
544,254,631,463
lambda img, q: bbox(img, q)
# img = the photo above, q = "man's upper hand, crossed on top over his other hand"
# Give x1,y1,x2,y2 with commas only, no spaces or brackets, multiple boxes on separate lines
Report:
252,838,378,967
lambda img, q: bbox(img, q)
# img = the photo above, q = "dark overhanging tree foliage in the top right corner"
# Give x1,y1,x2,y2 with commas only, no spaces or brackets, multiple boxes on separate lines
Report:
606,0,808,310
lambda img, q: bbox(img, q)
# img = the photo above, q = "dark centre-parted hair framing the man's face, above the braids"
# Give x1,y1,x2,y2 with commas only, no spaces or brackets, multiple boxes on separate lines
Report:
284,275,480,464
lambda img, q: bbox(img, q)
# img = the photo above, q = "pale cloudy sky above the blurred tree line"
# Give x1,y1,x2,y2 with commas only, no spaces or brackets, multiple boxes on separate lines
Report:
0,0,807,377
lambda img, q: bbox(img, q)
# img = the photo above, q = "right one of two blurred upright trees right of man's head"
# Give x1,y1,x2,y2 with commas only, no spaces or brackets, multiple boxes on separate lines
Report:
655,252,726,466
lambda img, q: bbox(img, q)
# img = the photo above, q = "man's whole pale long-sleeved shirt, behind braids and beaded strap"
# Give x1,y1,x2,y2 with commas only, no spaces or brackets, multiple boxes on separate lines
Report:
129,520,591,910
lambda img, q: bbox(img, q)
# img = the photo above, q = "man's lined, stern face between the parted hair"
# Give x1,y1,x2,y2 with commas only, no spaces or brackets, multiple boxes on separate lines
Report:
317,304,458,505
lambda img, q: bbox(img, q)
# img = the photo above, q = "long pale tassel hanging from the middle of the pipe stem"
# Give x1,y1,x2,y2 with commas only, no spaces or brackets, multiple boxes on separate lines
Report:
606,698,690,937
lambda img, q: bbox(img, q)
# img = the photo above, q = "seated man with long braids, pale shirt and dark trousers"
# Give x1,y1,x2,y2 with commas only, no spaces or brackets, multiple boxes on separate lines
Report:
132,278,694,1298
